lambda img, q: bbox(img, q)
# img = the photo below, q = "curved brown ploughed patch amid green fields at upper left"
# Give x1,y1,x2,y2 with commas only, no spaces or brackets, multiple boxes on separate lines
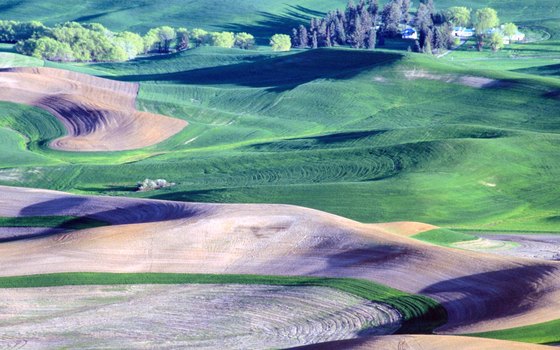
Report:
0,67,187,151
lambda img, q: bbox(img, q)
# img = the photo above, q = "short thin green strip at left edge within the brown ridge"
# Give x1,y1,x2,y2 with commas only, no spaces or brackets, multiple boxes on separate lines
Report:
0,216,109,230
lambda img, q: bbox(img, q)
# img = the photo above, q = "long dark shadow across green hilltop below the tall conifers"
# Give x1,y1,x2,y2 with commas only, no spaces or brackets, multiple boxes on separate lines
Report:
111,49,403,92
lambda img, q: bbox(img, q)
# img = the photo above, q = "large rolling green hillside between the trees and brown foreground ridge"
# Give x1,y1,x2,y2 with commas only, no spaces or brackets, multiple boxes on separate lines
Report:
3,49,560,230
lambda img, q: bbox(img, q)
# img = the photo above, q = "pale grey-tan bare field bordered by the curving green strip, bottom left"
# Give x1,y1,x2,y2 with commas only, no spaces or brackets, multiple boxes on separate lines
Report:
0,285,400,349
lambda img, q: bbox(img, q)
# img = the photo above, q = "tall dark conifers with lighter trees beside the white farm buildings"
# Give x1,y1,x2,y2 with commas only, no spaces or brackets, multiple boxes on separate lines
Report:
290,0,517,53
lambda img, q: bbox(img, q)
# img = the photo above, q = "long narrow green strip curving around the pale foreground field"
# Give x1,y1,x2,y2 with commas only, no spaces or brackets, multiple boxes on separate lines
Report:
0,273,447,333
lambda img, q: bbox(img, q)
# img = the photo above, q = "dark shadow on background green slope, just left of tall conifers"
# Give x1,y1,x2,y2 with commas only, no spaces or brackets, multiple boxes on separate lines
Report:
221,5,326,45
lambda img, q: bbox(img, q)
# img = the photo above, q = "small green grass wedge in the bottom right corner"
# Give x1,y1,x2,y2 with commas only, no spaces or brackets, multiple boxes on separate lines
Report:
467,320,560,344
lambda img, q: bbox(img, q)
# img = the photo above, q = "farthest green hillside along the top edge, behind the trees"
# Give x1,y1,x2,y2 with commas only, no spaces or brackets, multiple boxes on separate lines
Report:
0,0,560,36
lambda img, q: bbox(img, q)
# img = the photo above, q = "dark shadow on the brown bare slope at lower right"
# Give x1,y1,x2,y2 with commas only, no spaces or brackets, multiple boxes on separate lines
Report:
420,265,558,326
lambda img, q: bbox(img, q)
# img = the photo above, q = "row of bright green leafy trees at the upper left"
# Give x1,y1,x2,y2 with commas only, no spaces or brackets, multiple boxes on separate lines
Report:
0,21,255,62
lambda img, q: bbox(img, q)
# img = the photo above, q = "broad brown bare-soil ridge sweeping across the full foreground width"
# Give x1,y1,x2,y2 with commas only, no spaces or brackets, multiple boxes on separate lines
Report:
0,187,560,333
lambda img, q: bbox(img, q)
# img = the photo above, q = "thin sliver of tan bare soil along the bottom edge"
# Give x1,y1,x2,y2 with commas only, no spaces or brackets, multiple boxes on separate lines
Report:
298,335,556,350
